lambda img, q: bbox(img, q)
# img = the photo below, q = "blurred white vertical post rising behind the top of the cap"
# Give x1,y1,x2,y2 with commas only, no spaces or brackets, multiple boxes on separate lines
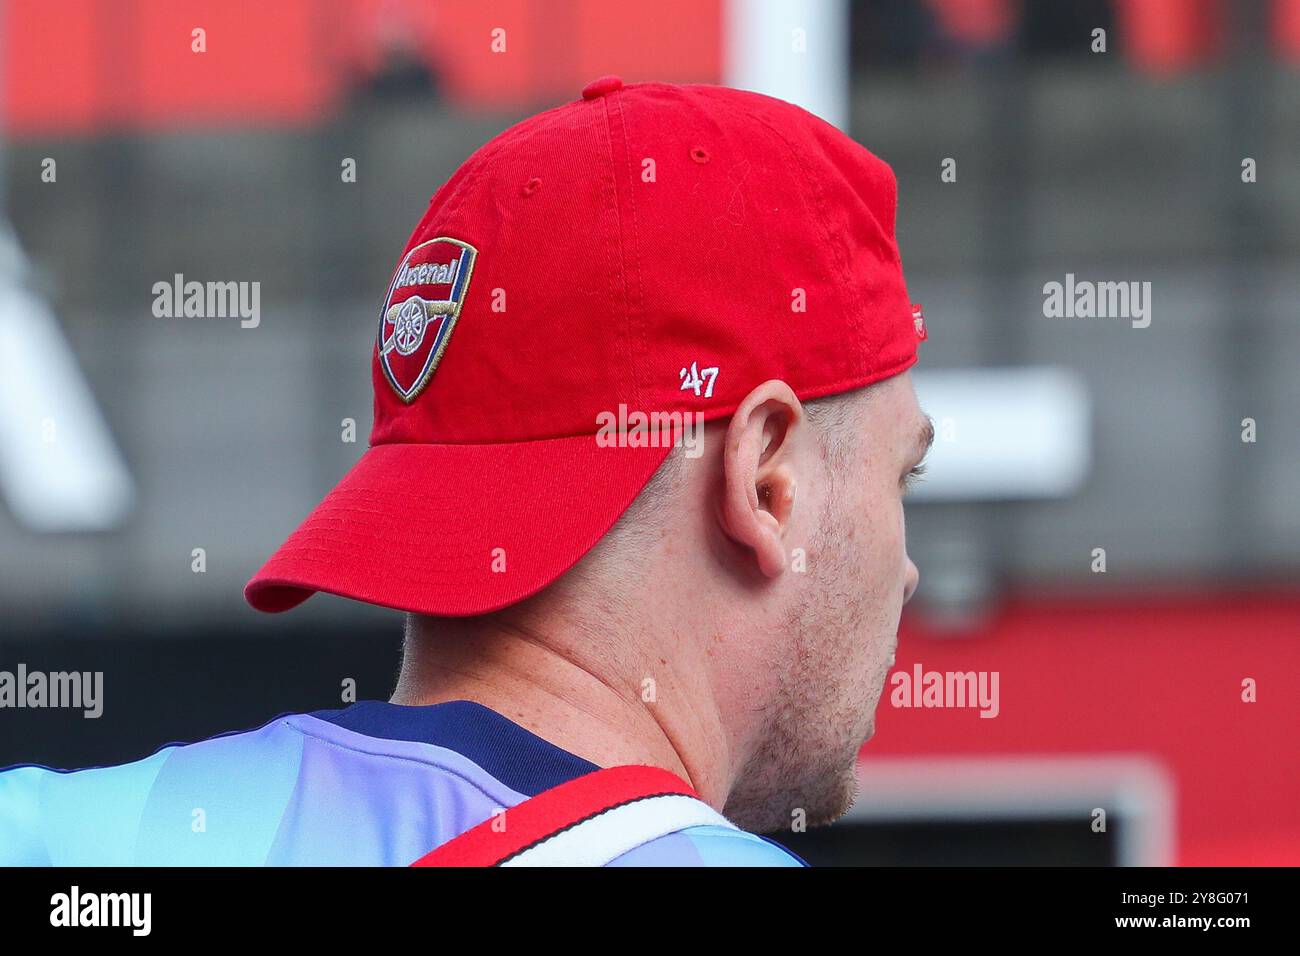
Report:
723,0,849,129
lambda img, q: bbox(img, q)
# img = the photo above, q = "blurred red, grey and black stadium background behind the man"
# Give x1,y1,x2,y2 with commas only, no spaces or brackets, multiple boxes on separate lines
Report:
0,0,1300,865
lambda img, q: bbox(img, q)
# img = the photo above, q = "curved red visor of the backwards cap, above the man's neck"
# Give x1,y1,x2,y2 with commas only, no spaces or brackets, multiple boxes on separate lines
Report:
244,434,671,617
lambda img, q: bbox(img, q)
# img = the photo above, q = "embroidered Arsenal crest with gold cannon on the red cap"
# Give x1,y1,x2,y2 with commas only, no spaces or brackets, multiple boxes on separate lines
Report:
378,237,478,403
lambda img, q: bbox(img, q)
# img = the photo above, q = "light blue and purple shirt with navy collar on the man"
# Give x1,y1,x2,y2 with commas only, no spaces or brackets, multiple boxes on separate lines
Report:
0,701,802,866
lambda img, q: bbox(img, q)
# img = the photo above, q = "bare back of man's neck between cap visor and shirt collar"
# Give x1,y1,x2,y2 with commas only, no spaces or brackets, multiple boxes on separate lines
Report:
393,619,732,810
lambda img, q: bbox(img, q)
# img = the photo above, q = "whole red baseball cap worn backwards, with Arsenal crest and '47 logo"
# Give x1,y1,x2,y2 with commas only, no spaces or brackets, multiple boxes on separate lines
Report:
244,77,926,615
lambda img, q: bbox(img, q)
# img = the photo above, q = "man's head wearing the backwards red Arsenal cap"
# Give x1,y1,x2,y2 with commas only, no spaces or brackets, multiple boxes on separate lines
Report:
246,77,926,823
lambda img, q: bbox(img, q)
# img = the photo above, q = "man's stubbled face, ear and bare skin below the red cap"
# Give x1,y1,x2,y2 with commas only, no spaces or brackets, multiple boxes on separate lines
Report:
412,373,933,830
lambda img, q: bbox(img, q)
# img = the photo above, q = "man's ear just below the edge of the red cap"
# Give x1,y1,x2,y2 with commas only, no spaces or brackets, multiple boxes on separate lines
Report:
719,378,807,578
